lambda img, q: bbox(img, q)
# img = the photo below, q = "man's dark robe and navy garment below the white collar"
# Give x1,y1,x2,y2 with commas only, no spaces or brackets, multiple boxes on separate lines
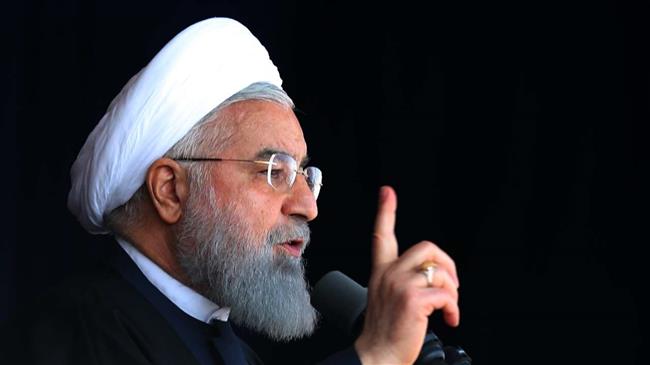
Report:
0,245,360,365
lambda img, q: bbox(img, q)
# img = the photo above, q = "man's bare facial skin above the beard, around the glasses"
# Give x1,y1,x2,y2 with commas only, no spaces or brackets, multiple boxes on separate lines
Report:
201,100,318,247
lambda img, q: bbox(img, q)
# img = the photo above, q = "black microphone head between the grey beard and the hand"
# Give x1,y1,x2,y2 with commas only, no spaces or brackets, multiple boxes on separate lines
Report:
311,271,368,336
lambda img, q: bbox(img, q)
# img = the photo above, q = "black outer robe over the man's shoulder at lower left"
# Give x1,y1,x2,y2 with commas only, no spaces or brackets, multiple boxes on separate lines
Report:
0,266,192,364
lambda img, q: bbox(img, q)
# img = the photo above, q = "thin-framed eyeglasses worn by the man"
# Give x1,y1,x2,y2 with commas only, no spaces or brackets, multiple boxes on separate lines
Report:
174,153,323,199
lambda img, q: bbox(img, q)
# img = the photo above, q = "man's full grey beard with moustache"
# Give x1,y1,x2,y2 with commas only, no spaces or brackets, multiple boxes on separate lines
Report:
177,189,318,341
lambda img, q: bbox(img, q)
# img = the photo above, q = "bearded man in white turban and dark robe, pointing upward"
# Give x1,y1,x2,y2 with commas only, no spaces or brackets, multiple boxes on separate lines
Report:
2,18,459,364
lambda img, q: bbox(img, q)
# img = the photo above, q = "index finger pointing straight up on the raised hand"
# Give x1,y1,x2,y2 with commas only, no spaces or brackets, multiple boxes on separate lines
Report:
372,186,398,268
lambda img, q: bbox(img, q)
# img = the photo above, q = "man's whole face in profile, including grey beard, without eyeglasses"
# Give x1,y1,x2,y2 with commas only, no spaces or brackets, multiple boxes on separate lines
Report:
177,101,317,340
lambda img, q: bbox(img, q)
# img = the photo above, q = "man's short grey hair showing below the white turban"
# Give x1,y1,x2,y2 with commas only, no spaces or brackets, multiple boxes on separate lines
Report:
104,82,295,238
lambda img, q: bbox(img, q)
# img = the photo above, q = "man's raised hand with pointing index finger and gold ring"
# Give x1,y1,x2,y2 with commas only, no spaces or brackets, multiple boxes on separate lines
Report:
354,186,460,365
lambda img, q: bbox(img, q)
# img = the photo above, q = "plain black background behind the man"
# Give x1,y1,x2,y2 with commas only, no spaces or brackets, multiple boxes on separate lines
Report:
0,0,650,364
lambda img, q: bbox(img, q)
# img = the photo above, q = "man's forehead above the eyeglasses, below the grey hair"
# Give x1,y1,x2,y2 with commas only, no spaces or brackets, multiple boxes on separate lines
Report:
215,100,307,161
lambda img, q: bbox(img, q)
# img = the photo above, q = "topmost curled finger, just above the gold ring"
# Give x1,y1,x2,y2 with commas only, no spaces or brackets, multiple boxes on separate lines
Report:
395,241,460,287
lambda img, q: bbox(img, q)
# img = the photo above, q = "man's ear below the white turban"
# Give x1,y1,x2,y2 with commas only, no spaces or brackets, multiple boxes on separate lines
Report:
145,158,189,224
